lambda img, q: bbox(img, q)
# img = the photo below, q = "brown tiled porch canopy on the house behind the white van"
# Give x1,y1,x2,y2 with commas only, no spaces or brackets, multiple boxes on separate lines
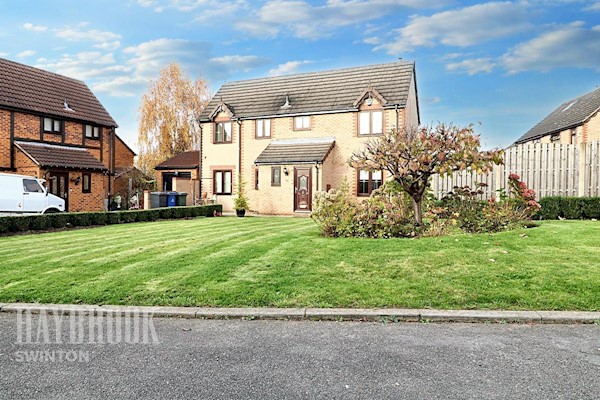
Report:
15,141,108,171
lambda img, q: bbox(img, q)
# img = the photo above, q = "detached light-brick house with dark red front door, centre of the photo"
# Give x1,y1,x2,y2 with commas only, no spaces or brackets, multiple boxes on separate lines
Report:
200,61,420,214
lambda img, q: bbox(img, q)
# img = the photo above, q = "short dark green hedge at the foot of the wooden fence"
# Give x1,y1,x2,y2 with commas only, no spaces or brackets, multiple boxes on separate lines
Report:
538,196,600,219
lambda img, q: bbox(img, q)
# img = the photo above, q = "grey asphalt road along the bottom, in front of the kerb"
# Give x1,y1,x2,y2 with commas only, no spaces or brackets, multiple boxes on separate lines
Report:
0,314,600,399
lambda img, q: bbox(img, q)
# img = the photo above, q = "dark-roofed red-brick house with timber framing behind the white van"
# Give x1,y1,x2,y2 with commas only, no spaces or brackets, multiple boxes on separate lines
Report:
0,59,135,211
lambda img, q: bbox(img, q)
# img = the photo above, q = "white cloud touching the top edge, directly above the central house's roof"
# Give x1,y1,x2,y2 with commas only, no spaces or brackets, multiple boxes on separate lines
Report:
235,0,444,39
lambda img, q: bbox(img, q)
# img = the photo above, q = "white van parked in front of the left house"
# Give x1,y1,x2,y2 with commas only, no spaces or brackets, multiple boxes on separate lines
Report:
0,173,65,214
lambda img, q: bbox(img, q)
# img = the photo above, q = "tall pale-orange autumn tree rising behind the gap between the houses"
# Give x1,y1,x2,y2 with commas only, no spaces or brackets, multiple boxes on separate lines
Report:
138,64,211,175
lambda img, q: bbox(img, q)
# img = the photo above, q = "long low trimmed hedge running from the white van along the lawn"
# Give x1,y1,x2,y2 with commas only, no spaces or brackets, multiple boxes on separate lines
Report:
0,204,223,234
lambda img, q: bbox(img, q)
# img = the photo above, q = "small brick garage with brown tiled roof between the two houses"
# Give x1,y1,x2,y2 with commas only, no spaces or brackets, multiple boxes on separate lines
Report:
154,150,200,206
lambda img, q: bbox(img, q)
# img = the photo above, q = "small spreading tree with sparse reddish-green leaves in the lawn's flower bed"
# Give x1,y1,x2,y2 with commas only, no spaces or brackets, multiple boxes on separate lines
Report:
349,124,502,225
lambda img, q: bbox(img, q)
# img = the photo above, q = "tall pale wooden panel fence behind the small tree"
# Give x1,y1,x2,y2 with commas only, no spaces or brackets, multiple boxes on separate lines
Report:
432,142,600,199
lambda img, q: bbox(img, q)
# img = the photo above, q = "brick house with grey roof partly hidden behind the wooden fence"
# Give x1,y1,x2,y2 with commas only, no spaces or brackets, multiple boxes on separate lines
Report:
516,88,600,144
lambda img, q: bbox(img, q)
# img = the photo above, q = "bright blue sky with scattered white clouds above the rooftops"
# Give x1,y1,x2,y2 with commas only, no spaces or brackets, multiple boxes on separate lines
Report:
0,0,600,148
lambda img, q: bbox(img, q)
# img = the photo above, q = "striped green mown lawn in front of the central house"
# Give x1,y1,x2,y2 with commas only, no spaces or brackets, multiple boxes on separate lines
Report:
0,218,600,310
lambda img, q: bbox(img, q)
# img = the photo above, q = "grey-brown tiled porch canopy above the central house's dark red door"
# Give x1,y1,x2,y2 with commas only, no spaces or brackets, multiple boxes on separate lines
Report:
254,137,335,165
